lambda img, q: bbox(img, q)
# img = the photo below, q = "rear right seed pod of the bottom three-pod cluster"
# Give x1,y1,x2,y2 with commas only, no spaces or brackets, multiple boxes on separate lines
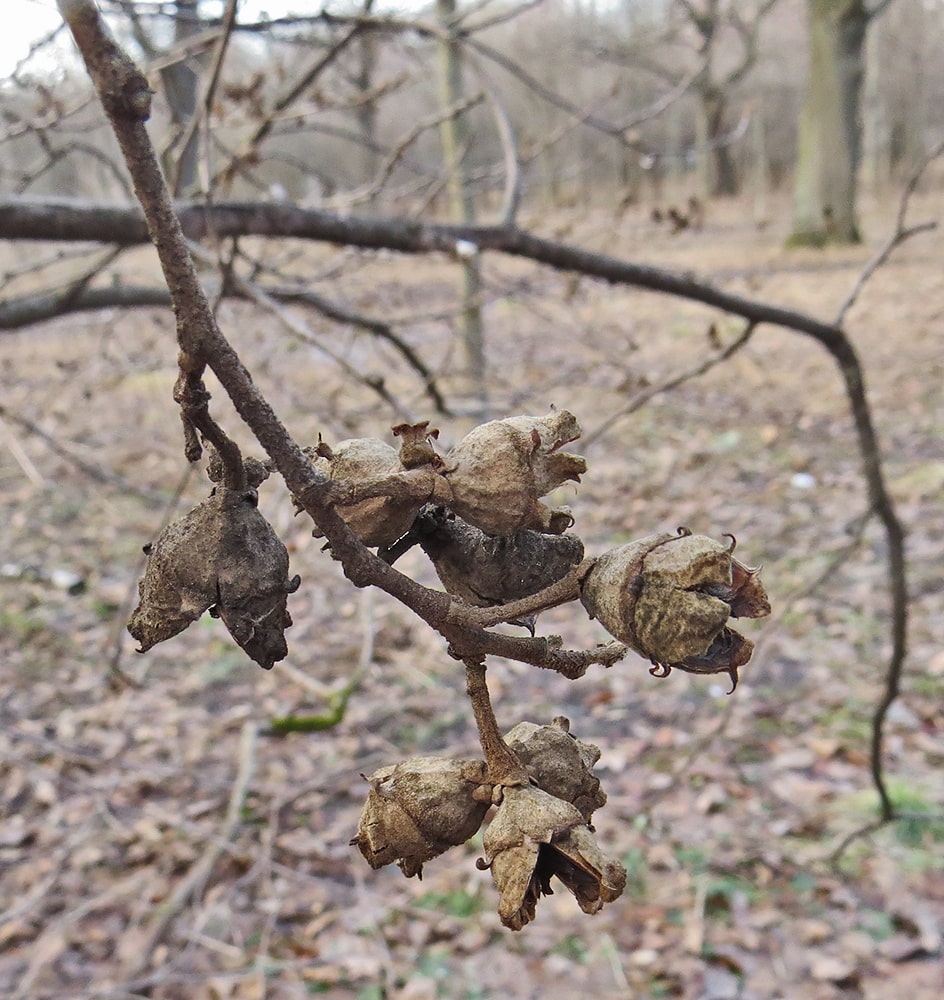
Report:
505,719,606,823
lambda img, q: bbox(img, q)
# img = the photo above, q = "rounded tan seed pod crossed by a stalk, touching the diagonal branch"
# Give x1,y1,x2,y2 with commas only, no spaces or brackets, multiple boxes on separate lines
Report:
308,438,423,546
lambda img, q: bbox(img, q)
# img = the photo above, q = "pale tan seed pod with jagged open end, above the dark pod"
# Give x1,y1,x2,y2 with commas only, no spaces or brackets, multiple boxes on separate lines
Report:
443,410,587,535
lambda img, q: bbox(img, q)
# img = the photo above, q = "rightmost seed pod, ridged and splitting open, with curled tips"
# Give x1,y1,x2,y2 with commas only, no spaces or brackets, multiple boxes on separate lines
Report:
581,529,770,691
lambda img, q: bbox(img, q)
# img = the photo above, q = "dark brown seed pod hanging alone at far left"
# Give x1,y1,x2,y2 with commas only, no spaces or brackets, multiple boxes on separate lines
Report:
128,486,300,669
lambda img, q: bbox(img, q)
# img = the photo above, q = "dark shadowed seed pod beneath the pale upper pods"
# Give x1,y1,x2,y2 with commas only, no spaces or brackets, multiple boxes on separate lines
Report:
413,505,583,607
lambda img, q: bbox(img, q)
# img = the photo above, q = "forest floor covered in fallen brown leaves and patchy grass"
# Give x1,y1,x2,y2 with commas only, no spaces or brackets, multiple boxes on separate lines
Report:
0,192,944,1000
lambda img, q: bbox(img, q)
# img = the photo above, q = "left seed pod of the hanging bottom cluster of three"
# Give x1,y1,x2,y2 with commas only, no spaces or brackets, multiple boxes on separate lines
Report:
351,757,491,878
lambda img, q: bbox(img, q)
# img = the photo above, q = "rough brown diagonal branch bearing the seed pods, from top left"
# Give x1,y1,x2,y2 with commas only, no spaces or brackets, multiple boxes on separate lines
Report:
58,0,626,678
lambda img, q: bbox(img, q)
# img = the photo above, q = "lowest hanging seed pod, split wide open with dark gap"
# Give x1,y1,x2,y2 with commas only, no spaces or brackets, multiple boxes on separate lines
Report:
478,785,626,931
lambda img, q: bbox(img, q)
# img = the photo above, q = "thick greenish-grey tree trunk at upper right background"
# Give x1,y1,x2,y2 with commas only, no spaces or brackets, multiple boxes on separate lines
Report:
789,0,869,246
